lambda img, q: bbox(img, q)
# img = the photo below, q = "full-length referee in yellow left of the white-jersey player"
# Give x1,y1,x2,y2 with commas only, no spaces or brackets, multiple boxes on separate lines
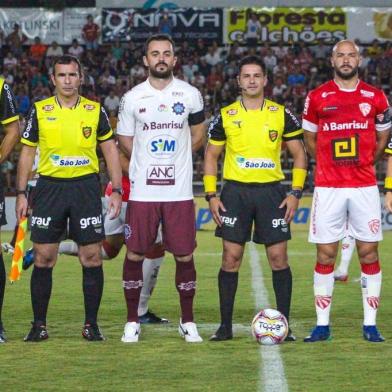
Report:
16,55,122,341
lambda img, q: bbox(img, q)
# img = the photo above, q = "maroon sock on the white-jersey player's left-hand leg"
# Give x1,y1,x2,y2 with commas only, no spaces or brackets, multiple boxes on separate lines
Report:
123,256,143,322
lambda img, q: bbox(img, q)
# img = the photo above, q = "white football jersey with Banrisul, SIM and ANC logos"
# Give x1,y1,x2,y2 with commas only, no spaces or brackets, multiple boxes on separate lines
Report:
117,78,204,201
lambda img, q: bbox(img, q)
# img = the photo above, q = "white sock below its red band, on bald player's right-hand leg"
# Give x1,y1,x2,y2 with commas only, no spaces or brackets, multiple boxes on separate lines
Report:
361,271,382,325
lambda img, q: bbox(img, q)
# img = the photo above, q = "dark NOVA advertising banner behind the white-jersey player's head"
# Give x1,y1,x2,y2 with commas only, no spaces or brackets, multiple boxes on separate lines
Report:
102,8,223,43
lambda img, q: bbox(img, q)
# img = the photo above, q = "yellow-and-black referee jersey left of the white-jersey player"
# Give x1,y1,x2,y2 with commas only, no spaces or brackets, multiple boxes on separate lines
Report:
21,96,113,179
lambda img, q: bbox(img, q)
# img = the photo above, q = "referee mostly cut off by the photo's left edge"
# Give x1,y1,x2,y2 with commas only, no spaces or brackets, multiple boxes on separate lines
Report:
0,78,20,344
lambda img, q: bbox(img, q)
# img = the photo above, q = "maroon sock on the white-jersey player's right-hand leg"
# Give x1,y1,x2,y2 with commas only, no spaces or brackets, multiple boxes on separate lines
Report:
176,258,196,323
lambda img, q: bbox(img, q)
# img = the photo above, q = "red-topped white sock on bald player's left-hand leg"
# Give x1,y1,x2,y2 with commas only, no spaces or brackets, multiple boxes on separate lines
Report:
313,263,335,325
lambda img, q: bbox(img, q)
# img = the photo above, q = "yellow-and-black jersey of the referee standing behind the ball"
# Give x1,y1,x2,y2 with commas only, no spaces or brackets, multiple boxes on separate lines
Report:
208,99,303,183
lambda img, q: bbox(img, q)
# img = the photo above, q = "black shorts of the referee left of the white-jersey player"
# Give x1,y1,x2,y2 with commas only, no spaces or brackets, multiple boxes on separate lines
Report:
31,175,105,245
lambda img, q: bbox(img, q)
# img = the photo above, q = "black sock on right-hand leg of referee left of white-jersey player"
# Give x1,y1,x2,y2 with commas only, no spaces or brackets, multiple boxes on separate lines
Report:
83,265,103,325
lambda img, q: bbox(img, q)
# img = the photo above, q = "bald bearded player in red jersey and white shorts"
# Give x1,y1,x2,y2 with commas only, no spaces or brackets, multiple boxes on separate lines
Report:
303,40,391,342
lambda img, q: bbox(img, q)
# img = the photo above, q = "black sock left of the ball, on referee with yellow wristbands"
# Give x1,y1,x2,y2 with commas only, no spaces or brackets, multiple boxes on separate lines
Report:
218,269,238,330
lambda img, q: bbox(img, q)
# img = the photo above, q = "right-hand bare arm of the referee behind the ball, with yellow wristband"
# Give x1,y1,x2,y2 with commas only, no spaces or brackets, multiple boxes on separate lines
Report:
279,139,306,223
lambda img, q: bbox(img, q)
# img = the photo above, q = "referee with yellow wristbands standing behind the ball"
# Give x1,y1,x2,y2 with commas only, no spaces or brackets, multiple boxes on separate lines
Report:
204,56,306,341
